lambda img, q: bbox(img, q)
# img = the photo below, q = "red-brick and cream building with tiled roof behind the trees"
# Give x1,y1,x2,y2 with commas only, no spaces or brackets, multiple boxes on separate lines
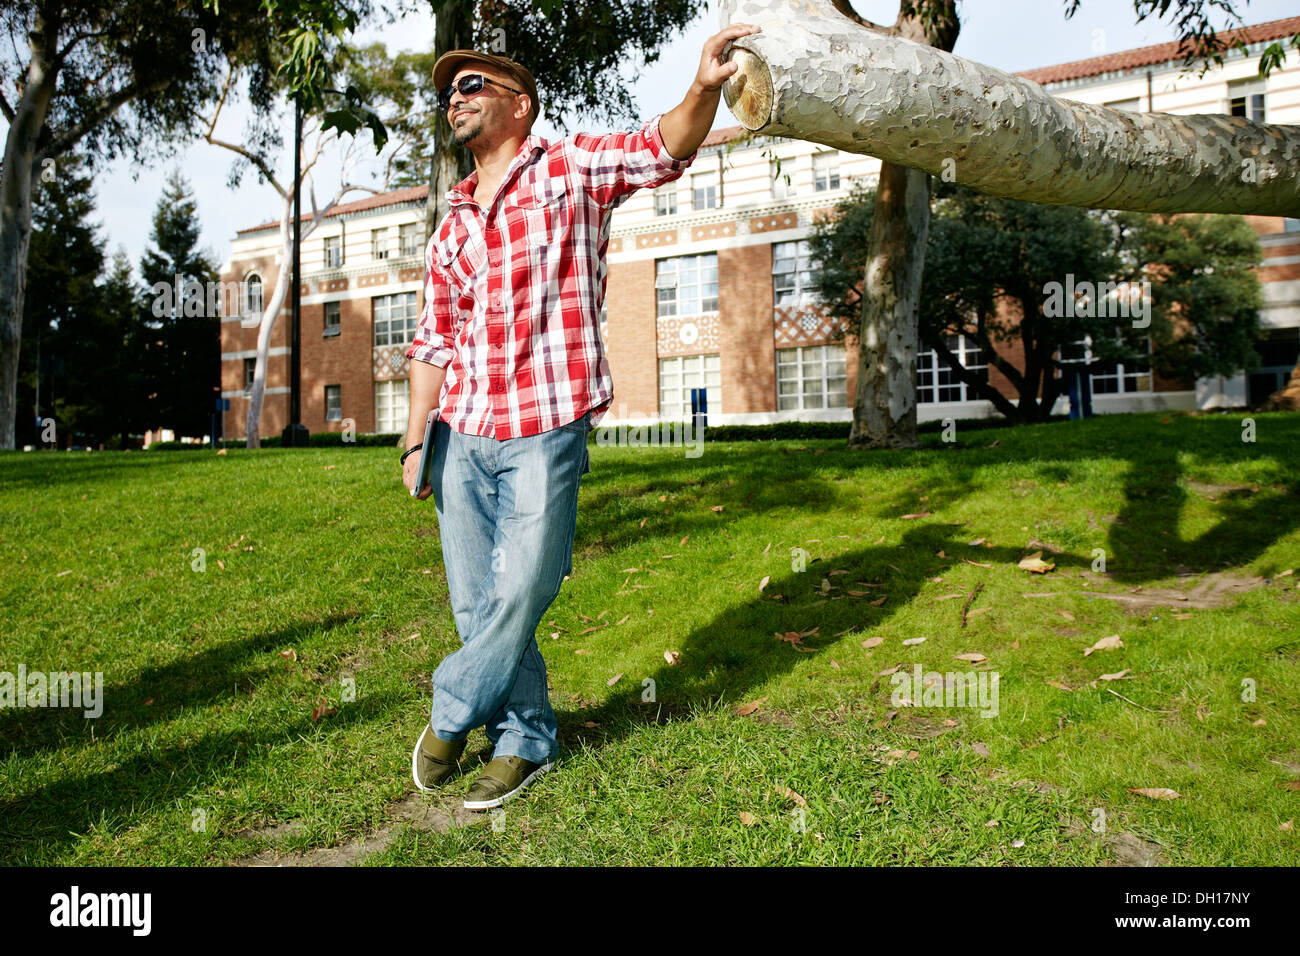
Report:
221,17,1300,437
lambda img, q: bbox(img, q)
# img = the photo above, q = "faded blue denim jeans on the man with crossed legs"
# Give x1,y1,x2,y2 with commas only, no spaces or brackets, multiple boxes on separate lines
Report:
429,414,592,763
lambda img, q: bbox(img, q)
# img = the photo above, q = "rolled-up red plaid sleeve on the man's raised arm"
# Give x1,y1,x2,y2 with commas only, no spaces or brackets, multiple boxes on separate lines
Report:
573,113,699,206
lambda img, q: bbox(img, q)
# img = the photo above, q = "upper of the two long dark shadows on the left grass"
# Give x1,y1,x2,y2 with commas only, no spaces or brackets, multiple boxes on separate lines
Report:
0,613,360,757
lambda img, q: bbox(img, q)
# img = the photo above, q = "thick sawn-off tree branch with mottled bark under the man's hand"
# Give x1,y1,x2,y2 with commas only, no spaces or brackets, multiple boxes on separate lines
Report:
722,0,1300,217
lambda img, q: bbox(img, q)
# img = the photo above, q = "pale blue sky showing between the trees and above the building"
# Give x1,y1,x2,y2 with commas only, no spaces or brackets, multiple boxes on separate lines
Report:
76,0,1296,274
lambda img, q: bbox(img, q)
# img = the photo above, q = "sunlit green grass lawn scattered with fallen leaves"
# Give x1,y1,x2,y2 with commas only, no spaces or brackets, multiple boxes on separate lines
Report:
0,414,1300,865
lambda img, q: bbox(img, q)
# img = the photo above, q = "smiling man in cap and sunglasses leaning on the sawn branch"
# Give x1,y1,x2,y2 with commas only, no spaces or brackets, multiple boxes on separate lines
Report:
403,23,757,810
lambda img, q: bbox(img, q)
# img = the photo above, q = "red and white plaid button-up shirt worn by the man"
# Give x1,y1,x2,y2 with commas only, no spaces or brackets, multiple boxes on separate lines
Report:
406,113,698,440
